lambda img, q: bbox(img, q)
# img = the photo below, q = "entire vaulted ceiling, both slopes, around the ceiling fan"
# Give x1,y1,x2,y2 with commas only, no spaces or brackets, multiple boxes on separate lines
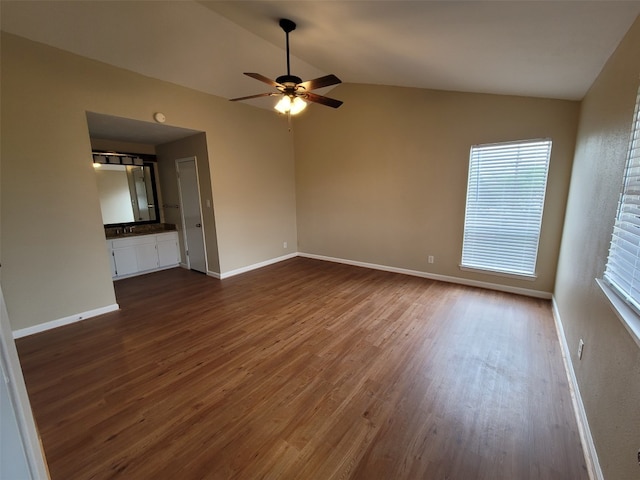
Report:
0,0,640,142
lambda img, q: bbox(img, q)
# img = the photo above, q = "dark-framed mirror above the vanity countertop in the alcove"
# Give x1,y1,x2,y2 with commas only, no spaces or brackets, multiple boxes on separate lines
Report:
93,158,160,226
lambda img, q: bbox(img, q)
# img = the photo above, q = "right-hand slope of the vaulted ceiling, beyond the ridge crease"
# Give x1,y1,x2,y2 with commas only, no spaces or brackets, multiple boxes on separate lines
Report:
201,0,640,100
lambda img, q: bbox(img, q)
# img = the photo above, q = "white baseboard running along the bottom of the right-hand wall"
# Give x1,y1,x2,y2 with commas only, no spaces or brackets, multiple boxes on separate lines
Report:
551,296,604,480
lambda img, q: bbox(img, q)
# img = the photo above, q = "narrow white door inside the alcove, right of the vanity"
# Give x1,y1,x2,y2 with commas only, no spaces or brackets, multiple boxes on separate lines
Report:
176,157,207,273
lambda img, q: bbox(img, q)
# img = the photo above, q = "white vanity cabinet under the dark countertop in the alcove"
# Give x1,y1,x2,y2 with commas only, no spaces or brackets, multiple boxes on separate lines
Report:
107,232,180,278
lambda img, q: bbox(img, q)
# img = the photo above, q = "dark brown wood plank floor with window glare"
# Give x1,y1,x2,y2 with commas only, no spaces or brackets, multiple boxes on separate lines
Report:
17,258,588,480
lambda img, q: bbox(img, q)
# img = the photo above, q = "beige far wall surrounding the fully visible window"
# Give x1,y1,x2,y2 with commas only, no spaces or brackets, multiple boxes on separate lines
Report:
295,84,579,293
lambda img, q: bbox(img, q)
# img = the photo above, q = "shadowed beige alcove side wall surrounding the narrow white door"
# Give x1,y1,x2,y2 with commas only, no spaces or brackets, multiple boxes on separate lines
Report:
156,133,220,274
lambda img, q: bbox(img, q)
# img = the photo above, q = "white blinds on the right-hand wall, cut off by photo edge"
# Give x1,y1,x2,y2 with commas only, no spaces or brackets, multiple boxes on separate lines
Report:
604,89,640,312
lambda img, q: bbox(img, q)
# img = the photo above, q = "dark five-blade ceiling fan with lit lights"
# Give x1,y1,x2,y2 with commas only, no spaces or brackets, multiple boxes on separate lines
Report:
231,18,342,115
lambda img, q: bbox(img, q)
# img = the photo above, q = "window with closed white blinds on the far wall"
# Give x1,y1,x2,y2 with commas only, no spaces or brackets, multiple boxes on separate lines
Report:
461,139,551,278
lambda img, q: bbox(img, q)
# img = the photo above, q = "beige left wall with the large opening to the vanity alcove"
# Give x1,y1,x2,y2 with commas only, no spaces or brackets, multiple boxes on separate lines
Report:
0,33,296,330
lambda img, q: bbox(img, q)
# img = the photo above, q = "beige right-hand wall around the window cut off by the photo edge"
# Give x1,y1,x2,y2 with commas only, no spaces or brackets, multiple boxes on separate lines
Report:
555,15,640,479
